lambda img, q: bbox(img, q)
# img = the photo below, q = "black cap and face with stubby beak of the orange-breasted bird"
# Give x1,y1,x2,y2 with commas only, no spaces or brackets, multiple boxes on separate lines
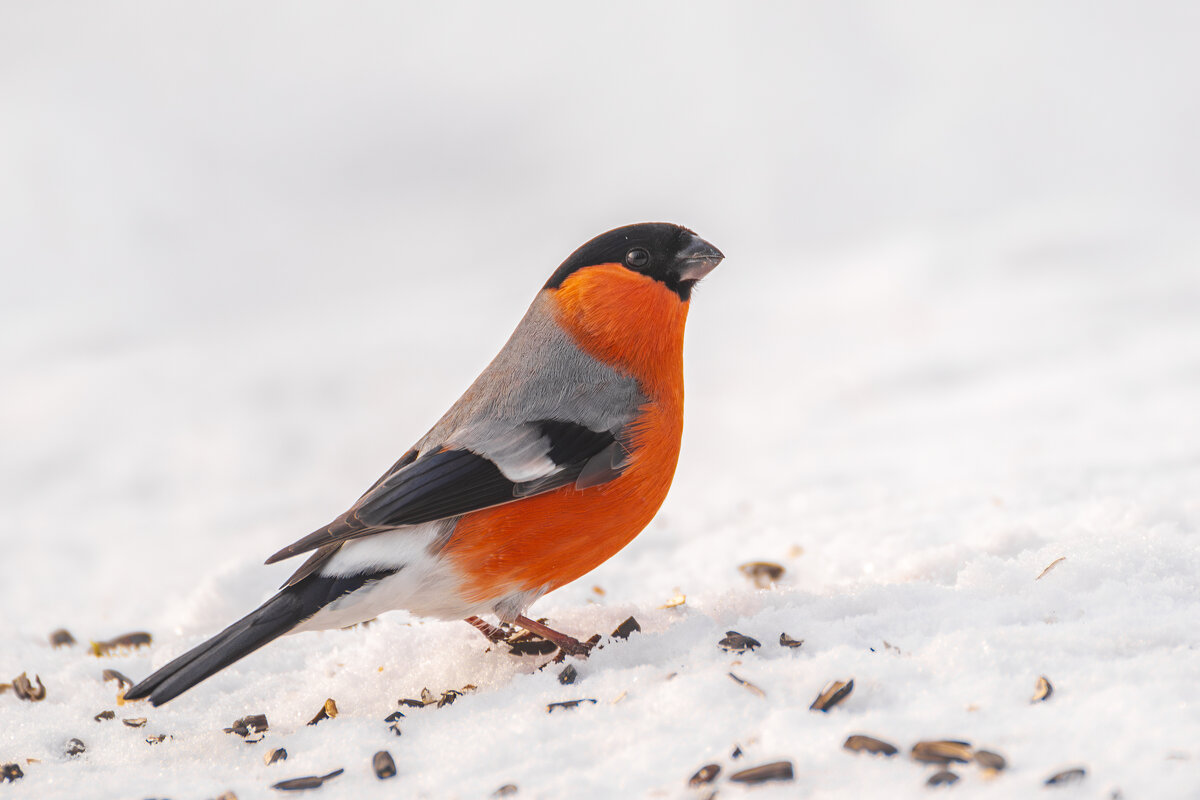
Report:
546,222,725,300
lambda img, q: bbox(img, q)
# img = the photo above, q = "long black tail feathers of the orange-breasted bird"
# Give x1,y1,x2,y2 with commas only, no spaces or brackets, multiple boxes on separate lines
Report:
125,571,392,705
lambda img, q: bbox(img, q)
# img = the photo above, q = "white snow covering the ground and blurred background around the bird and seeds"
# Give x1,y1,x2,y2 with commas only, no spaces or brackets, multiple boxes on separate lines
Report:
0,0,1200,800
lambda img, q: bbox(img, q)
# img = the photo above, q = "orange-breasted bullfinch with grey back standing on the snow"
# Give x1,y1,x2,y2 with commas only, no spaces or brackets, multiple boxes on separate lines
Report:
125,222,725,705
